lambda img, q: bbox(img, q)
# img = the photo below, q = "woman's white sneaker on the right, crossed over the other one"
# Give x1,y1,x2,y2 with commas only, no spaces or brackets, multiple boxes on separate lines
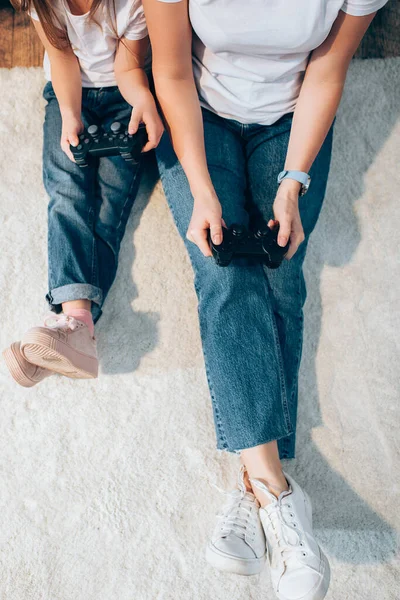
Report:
250,473,330,600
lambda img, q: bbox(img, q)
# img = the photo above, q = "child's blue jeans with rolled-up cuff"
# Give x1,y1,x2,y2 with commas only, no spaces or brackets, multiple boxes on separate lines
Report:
43,82,142,321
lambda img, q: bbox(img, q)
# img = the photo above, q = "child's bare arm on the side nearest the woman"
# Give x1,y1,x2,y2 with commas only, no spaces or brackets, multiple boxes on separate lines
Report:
114,37,164,152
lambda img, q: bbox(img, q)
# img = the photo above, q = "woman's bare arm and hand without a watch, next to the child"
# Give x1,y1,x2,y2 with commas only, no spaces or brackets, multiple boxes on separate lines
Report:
143,0,222,256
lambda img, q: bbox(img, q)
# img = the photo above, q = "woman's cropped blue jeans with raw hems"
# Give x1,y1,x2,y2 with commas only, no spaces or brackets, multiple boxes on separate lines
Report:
156,110,332,458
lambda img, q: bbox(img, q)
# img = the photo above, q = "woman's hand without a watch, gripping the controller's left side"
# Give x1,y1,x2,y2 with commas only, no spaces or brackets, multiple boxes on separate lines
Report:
186,192,226,256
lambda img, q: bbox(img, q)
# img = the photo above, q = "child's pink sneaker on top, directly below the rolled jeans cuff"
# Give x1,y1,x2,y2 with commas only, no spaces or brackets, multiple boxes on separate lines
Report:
21,314,98,379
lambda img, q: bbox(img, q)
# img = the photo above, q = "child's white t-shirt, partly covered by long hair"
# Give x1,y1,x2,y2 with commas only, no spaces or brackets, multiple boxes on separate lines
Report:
30,0,147,88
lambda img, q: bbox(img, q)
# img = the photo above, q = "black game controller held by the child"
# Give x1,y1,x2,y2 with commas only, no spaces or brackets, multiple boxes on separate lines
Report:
70,121,148,167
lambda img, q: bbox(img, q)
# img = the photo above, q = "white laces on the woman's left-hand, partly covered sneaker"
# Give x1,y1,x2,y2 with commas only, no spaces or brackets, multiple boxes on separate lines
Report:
213,466,258,539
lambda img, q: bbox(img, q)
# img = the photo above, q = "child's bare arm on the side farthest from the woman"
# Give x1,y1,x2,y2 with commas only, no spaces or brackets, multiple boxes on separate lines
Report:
32,19,83,160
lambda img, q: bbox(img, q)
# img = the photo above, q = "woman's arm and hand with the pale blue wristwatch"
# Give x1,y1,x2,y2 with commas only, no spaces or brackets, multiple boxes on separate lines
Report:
274,11,375,258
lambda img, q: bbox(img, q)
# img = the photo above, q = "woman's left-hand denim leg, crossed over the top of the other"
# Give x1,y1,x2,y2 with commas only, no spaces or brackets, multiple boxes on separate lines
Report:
156,111,292,451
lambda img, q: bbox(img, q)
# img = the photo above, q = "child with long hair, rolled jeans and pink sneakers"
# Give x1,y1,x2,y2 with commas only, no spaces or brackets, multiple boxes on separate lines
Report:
4,0,163,387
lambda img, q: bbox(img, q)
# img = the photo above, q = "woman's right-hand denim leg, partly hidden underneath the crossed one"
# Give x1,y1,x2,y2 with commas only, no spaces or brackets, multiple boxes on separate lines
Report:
246,115,332,458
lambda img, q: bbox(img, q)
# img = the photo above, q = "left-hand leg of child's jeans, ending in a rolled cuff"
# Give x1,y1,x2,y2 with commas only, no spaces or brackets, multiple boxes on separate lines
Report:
43,84,102,322
